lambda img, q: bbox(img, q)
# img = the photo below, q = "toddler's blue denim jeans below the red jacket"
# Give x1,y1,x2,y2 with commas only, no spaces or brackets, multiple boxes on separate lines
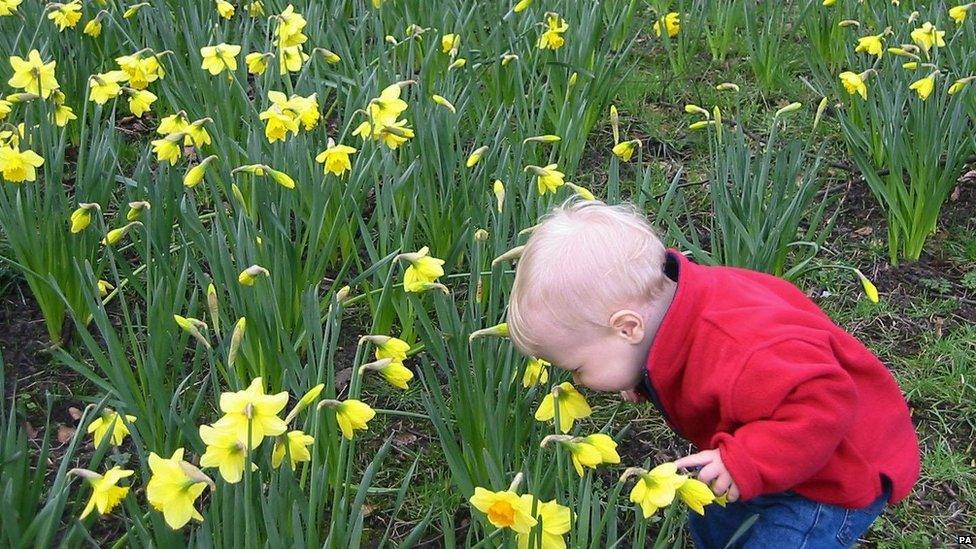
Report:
688,477,891,549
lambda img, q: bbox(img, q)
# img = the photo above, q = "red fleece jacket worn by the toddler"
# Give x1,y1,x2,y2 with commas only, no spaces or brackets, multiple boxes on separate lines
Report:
647,250,920,508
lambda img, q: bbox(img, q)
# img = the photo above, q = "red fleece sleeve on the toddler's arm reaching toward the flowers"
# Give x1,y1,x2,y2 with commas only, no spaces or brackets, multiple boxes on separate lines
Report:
711,339,857,501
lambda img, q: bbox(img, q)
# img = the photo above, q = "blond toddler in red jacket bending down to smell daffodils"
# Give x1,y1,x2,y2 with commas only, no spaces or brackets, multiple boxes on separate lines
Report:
507,199,920,548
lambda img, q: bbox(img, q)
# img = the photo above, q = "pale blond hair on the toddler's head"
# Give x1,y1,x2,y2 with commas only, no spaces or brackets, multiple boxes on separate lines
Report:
507,197,666,356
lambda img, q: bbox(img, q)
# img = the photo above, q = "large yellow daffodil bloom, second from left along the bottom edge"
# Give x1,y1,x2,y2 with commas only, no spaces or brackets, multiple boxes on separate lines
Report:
146,448,212,530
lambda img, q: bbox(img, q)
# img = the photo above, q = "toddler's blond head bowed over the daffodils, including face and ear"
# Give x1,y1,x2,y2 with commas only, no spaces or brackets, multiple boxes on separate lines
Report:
508,199,673,391
